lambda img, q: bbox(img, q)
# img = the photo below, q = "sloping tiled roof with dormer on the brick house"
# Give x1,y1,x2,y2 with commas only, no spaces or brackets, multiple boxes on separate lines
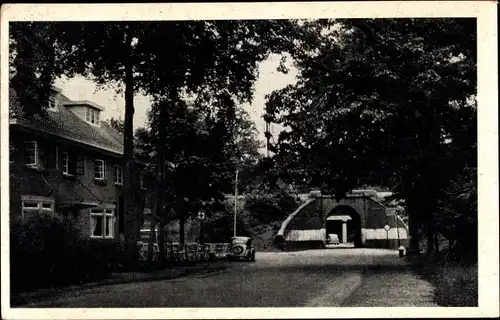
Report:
9,89,123,154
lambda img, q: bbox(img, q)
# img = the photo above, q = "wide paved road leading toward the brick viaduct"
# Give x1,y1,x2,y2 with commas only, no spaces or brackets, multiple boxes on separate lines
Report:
24,248,433,308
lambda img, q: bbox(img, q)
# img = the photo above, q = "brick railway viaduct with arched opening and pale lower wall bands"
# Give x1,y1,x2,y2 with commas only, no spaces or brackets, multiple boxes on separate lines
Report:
275,190,408,250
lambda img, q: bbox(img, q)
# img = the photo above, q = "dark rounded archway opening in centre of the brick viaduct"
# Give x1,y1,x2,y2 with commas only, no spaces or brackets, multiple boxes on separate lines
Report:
325,205,363,248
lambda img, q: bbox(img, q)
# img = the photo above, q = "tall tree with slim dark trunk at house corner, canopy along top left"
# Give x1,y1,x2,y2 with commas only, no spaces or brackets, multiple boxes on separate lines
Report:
11,20,296,249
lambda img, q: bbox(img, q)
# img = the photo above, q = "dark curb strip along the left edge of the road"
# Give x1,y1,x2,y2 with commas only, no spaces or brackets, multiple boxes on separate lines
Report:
10,266,227,308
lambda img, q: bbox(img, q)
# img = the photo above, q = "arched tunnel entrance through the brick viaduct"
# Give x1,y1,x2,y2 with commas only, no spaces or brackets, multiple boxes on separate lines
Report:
325,206,363,248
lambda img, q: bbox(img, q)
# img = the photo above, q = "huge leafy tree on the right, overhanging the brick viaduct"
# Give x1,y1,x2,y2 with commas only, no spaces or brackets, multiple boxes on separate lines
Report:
266,19,477,258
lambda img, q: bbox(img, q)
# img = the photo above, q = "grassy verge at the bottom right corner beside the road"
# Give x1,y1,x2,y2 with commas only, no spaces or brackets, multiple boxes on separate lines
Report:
416,258,478,307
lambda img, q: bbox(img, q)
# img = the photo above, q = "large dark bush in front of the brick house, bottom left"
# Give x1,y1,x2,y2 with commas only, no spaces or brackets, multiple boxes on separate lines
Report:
10,212,116,292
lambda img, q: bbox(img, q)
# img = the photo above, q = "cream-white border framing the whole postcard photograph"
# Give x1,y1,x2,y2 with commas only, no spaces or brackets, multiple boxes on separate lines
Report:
0,1,500,319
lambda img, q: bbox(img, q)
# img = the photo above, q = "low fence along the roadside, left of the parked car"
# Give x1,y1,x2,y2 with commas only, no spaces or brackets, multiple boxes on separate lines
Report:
138,242,230,264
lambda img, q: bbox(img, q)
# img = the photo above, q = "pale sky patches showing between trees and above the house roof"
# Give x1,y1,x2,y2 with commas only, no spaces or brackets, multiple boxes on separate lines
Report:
55,55,297,151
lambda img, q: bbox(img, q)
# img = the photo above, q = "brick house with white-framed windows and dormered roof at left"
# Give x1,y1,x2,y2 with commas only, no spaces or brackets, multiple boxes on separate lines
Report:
9,88,147,240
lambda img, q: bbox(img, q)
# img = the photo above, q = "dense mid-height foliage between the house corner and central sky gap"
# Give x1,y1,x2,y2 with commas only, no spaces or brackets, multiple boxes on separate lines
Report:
136,87,266,235
